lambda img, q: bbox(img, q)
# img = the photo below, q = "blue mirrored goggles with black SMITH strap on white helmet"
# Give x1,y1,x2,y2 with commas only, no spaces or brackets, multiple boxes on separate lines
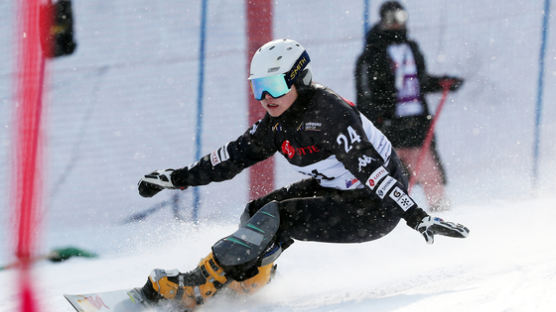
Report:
249,51,310,101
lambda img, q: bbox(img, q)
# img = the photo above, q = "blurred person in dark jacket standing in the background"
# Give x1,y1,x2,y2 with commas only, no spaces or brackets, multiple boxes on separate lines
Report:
355,1,463,211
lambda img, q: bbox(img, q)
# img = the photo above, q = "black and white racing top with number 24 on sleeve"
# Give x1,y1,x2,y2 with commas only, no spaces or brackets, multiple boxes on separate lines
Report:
172,84,422,226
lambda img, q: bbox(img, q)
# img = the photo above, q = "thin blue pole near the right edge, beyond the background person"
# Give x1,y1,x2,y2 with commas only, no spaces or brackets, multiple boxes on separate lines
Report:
533,0,550,187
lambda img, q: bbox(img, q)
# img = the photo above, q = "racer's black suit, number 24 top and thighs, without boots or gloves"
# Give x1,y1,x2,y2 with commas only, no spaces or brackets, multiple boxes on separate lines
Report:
172,84,426,243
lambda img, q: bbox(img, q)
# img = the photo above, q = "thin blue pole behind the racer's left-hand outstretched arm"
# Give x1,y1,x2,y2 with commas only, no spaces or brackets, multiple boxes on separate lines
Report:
192,0,208,223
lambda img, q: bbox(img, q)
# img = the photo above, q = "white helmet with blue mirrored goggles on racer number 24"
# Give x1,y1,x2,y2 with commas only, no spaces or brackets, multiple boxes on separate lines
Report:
248,39,312,100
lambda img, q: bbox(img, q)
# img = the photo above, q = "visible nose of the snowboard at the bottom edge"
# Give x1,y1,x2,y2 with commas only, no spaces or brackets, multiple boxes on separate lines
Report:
64,288,158,312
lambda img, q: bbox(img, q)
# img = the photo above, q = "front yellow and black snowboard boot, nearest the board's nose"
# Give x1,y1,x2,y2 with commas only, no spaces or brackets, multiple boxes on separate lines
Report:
142,253,228,311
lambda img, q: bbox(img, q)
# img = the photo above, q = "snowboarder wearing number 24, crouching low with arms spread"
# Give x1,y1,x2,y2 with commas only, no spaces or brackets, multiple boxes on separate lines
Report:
139,39,469,309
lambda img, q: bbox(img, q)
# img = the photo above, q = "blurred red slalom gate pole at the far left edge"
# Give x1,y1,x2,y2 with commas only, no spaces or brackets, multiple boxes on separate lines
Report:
10,0,51,312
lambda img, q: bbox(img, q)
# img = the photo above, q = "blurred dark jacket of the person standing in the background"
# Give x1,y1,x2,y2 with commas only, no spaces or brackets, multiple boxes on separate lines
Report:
355,24,442,148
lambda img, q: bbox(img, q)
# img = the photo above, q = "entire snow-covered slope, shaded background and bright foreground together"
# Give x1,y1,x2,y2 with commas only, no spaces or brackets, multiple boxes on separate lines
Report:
0,0,556,312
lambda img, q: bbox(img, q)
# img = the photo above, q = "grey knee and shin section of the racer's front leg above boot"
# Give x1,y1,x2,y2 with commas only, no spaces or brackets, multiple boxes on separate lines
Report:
212,201,293,281
